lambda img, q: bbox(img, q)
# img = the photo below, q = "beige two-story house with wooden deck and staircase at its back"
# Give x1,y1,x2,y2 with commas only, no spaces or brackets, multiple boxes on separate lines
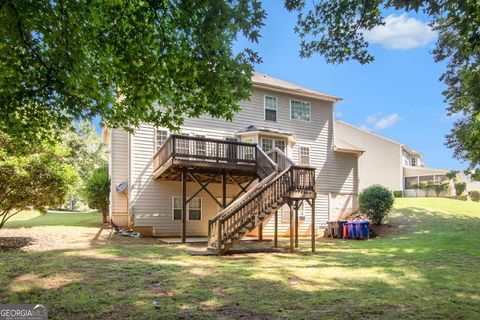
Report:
104,73,362,249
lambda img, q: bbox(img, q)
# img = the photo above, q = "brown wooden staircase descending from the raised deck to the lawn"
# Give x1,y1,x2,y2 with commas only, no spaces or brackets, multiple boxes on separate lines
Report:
208,146,315,255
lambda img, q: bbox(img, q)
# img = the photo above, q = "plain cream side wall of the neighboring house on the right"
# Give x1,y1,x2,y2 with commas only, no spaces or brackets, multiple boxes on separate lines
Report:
335,122,403,191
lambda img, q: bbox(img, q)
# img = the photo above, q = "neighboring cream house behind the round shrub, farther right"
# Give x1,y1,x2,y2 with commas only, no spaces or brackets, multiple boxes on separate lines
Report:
335,121,449,197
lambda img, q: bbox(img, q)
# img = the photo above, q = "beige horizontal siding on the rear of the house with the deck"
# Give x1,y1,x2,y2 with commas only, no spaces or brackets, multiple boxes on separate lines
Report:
109,89,357,236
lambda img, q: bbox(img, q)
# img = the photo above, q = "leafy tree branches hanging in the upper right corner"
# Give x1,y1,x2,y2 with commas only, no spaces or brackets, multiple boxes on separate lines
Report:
285,0,480,178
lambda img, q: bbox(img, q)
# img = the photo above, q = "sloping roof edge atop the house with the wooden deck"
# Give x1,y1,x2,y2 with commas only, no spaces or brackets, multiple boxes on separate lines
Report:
252,72,342,103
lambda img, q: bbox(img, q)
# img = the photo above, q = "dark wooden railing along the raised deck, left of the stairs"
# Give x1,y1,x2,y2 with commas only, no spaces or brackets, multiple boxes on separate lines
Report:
153,134,257,170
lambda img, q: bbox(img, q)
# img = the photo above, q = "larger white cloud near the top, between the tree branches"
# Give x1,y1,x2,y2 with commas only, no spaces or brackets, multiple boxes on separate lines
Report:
364,13,436,50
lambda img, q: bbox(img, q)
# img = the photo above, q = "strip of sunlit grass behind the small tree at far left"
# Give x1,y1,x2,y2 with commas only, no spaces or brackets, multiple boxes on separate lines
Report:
6,211,101,228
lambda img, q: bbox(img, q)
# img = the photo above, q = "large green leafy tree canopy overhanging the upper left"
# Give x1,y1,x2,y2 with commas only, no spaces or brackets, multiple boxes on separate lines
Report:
0,0,265,144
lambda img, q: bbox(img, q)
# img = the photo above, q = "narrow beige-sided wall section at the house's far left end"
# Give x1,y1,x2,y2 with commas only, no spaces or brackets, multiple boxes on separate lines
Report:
110,129,128,225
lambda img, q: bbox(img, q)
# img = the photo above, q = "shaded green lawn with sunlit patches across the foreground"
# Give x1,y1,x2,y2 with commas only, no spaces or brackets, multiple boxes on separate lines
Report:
0,198,480,319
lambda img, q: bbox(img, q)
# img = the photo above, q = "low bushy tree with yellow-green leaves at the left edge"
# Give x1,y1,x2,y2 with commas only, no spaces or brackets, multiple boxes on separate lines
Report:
0,135,76,229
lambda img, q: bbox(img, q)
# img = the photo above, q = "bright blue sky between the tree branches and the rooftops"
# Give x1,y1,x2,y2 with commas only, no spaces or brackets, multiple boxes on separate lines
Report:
237,1,465,169
